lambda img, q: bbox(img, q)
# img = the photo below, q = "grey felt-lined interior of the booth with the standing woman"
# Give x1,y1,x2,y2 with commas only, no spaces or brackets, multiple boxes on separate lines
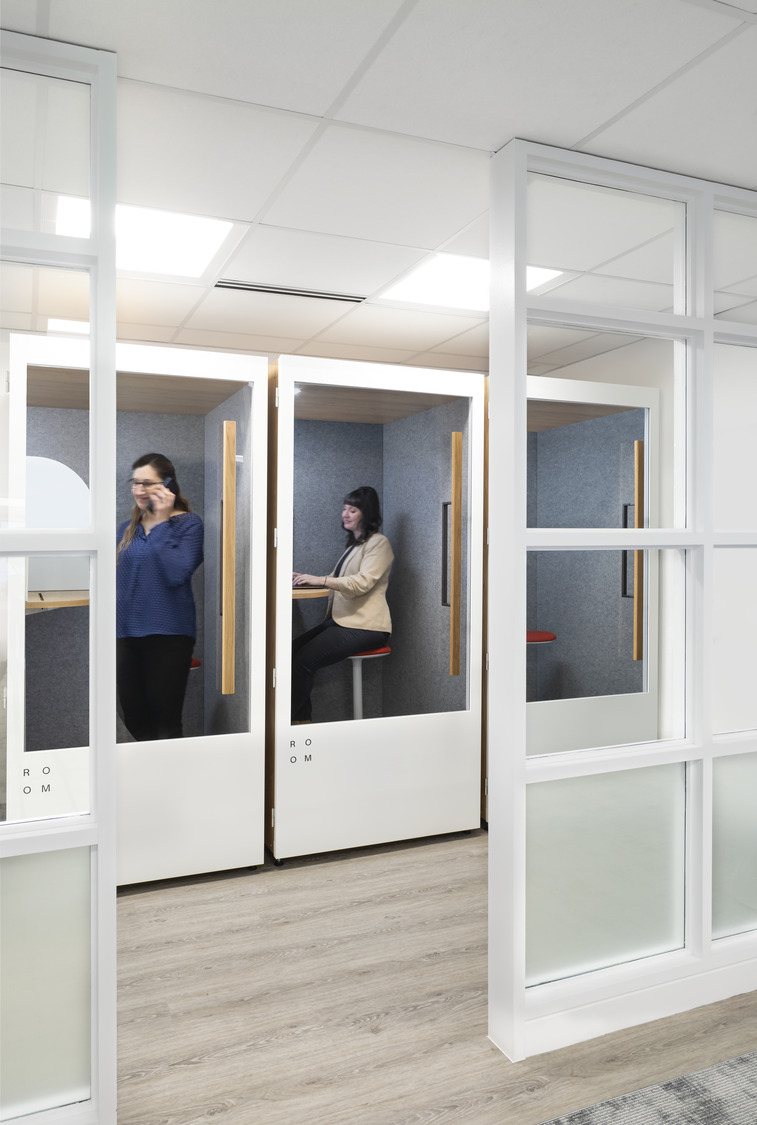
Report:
26,367,253,750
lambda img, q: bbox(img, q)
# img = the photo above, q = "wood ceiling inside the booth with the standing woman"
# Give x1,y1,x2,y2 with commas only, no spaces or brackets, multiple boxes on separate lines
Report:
27,367,244,415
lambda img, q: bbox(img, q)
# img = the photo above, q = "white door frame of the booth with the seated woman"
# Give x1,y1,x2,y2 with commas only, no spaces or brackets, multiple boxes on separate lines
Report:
270,356,484,858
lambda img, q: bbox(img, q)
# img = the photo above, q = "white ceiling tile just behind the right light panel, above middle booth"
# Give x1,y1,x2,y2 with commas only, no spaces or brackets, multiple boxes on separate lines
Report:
310,305,476,351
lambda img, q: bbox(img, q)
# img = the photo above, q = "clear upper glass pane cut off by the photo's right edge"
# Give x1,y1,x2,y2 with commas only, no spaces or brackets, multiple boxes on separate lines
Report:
713,212,757,324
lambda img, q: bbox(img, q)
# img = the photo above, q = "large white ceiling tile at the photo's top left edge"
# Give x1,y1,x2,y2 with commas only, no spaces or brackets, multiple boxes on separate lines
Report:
13,0,403,115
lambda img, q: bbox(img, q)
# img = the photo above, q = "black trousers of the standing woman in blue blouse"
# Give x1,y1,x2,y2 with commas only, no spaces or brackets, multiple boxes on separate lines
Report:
116,633,195,743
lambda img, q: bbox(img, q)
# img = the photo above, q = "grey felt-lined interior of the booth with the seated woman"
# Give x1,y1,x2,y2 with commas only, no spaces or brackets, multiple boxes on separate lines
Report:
292,383,470,722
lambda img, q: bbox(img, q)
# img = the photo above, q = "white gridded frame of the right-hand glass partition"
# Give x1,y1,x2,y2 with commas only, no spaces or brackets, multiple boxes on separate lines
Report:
488,141,757,1059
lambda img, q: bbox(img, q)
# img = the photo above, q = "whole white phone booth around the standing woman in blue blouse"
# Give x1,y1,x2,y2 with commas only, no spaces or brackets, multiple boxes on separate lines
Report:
9,338,268,884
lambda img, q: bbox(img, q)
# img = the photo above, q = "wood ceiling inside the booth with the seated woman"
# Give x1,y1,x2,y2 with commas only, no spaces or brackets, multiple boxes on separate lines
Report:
295,384,457,425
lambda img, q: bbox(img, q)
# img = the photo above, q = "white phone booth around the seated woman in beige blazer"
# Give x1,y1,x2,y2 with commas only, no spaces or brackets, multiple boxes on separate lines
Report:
267,357,484,860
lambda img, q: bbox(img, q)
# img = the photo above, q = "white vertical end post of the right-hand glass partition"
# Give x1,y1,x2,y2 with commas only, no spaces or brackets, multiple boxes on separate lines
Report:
488,142,528,1060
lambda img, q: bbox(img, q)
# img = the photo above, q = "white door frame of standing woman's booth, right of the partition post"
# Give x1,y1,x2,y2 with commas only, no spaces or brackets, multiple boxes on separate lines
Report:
114,343,268,885
